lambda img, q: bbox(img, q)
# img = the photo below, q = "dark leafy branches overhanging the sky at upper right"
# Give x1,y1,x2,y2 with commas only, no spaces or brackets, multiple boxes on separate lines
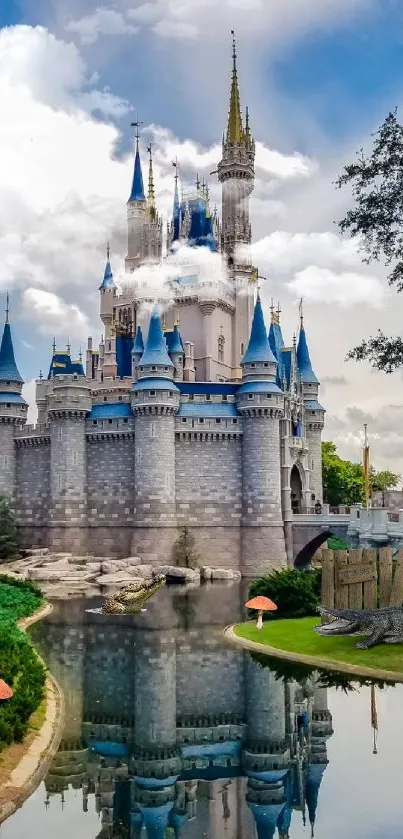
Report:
336,111,403,373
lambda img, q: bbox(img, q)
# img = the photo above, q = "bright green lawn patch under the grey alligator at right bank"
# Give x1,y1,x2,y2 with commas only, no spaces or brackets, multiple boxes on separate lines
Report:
234,618,403,673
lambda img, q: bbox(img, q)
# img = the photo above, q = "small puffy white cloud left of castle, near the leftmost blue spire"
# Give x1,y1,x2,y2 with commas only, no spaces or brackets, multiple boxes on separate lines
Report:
21,288,90,341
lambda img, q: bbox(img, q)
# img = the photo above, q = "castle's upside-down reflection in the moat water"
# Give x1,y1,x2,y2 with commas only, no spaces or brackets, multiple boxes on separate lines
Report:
32,584,332,839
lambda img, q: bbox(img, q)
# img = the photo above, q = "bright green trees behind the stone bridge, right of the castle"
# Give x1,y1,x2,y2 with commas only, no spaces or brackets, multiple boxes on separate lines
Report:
322,442,401,507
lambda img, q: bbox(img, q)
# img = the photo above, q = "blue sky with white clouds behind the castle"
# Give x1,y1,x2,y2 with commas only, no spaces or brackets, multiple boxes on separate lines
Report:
0,0,403,468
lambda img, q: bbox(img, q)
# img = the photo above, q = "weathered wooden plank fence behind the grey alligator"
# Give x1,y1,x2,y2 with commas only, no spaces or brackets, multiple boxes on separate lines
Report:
321,548,403,609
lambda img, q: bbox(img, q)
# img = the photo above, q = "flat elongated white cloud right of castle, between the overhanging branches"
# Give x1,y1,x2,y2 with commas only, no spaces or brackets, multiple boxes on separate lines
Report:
287,265,385,308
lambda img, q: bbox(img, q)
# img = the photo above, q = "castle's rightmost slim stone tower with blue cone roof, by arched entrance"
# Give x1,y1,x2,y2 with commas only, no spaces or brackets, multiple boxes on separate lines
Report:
297,311,325,504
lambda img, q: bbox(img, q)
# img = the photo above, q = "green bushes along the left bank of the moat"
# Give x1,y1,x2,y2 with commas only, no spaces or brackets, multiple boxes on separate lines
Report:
0,574,46,752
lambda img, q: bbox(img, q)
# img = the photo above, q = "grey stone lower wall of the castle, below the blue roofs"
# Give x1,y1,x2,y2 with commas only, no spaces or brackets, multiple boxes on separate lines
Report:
7,414,314,575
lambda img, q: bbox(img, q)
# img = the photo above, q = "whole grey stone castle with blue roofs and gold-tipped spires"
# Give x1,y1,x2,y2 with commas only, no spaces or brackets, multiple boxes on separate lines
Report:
0,41,324,576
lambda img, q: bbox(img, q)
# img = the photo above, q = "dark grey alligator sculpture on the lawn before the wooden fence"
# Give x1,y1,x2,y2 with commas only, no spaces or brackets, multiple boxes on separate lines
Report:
315,606,403,650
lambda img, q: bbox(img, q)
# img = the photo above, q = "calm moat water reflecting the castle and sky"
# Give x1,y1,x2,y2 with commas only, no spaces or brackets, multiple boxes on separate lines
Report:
0,583,403,839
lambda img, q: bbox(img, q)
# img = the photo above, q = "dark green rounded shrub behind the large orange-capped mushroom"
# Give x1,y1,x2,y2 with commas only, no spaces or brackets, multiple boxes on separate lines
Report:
249,568,322,620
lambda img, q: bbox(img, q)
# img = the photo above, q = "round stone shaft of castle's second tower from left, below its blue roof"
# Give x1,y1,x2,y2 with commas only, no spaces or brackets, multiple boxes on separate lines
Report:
48,373,92,554
